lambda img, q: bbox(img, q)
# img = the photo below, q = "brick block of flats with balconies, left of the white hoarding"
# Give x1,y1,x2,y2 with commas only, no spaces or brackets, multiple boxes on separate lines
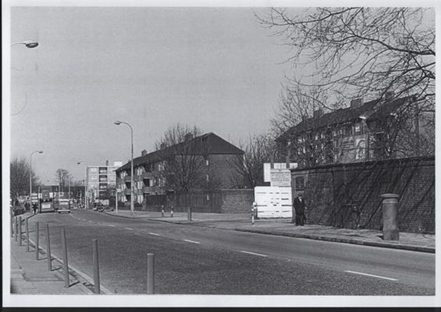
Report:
116,133,244,204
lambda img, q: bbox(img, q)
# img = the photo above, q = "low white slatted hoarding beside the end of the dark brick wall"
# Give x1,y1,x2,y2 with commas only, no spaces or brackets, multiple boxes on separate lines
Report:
254,186,292,218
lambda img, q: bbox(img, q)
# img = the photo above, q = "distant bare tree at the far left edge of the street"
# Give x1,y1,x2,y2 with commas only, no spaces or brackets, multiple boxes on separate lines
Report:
10,157,39,198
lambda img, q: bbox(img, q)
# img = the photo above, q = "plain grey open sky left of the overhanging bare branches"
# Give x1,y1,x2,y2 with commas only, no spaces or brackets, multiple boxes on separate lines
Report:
6,6,296,184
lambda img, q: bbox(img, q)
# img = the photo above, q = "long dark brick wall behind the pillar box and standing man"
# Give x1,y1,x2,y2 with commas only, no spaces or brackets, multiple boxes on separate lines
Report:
292,157,435,233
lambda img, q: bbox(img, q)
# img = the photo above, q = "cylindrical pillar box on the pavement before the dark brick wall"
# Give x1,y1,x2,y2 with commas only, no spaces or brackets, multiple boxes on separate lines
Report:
380,193,400,240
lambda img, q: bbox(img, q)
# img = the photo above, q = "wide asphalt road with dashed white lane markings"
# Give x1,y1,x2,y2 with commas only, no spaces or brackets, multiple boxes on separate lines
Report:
25,210,435,296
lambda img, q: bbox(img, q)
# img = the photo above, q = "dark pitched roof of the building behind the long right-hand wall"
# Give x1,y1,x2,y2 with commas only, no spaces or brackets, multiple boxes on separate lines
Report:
276,96,411,141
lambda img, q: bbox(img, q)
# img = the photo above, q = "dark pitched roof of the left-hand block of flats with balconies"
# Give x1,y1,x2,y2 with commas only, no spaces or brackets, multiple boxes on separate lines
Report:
116,132,244,172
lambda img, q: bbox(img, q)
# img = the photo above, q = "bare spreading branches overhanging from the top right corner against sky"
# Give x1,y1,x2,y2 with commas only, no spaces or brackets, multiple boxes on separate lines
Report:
258,7,435,100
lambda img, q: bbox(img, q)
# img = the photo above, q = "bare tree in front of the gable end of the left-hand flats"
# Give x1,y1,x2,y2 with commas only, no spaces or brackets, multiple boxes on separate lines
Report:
156,124,207,194
